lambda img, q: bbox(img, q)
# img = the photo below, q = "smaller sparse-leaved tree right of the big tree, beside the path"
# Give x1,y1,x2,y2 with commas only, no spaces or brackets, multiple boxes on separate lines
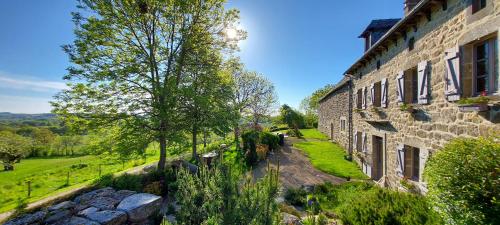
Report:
226,59,277,143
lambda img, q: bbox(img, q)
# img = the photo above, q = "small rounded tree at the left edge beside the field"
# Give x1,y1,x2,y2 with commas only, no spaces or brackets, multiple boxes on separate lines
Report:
0,131,30,171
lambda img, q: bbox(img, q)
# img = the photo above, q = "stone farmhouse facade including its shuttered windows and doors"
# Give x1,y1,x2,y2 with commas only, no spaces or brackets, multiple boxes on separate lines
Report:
319,0,500,192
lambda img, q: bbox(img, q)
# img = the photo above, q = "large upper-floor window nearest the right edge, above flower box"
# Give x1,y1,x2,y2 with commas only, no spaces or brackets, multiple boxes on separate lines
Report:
473,39,498,95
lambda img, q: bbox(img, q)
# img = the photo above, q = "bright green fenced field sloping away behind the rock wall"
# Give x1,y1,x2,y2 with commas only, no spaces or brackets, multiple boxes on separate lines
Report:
0,150,159,212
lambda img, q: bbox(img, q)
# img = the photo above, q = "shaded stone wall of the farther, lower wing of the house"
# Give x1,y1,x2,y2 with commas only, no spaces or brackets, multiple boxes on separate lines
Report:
318,80,349,150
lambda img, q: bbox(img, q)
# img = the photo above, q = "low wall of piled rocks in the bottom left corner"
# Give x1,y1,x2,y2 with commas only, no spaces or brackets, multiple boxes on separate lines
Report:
5,188,162,225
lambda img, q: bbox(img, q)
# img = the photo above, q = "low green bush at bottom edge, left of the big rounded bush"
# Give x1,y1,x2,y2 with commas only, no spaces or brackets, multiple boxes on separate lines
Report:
338,188,441,225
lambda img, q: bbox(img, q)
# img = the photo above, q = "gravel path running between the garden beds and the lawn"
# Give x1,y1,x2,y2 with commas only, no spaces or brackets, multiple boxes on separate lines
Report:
252,139,346,189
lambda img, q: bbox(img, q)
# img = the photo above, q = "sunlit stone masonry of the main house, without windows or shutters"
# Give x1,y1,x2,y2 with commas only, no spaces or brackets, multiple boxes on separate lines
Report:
319,0,500,192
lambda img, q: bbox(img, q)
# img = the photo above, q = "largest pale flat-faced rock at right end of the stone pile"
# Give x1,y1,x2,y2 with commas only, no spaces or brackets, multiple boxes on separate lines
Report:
116,193,162,222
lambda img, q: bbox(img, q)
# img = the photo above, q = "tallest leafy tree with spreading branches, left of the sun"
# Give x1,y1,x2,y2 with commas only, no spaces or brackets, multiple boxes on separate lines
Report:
53,0,245,170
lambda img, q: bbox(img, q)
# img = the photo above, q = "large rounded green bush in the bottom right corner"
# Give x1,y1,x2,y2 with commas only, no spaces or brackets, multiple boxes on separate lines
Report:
425,138,500,224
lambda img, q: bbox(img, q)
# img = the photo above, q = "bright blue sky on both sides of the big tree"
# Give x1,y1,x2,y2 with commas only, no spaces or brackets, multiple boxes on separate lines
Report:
0,0,404,113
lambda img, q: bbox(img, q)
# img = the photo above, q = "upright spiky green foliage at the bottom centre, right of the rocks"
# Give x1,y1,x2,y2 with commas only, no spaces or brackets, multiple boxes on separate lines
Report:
177,165,279,225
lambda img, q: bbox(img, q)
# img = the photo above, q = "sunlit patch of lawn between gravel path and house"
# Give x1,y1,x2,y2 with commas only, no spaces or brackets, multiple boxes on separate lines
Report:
294,129,367,179
